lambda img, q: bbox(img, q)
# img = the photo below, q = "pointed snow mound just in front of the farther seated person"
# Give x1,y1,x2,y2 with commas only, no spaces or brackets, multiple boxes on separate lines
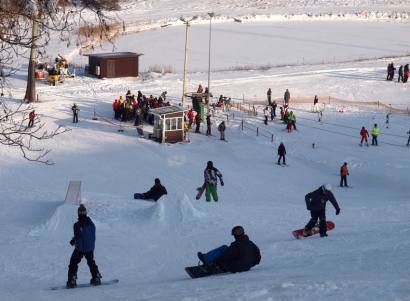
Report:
138,194,206,226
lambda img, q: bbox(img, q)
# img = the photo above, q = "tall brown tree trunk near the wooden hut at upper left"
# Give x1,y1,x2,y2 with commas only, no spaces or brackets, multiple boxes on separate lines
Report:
24,1,39,102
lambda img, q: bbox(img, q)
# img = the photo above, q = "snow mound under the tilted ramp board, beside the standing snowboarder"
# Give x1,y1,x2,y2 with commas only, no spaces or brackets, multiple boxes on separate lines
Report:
29,203,77,237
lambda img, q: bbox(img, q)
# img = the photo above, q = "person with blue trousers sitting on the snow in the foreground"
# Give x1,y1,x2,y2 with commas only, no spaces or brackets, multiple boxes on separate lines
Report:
198,226,261,273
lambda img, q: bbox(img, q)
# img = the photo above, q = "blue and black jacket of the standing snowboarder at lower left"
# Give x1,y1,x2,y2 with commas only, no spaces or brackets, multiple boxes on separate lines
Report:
74,216,95,252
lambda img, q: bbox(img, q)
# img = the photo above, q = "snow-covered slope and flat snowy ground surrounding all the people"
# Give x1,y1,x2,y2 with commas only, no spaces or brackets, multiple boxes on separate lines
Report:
0,0,410,301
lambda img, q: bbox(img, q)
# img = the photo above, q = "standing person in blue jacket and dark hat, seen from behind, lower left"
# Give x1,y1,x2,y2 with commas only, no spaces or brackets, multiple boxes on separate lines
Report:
66,204,102,288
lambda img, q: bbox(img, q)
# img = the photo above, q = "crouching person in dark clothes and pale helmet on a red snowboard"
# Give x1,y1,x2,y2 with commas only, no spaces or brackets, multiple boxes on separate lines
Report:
303,184,340,237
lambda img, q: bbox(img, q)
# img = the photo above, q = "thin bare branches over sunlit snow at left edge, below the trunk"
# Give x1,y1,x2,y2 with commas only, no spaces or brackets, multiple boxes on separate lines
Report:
0,97,70,165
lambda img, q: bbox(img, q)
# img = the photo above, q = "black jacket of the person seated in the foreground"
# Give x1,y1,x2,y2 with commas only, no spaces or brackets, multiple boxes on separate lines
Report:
216,235,261,273
